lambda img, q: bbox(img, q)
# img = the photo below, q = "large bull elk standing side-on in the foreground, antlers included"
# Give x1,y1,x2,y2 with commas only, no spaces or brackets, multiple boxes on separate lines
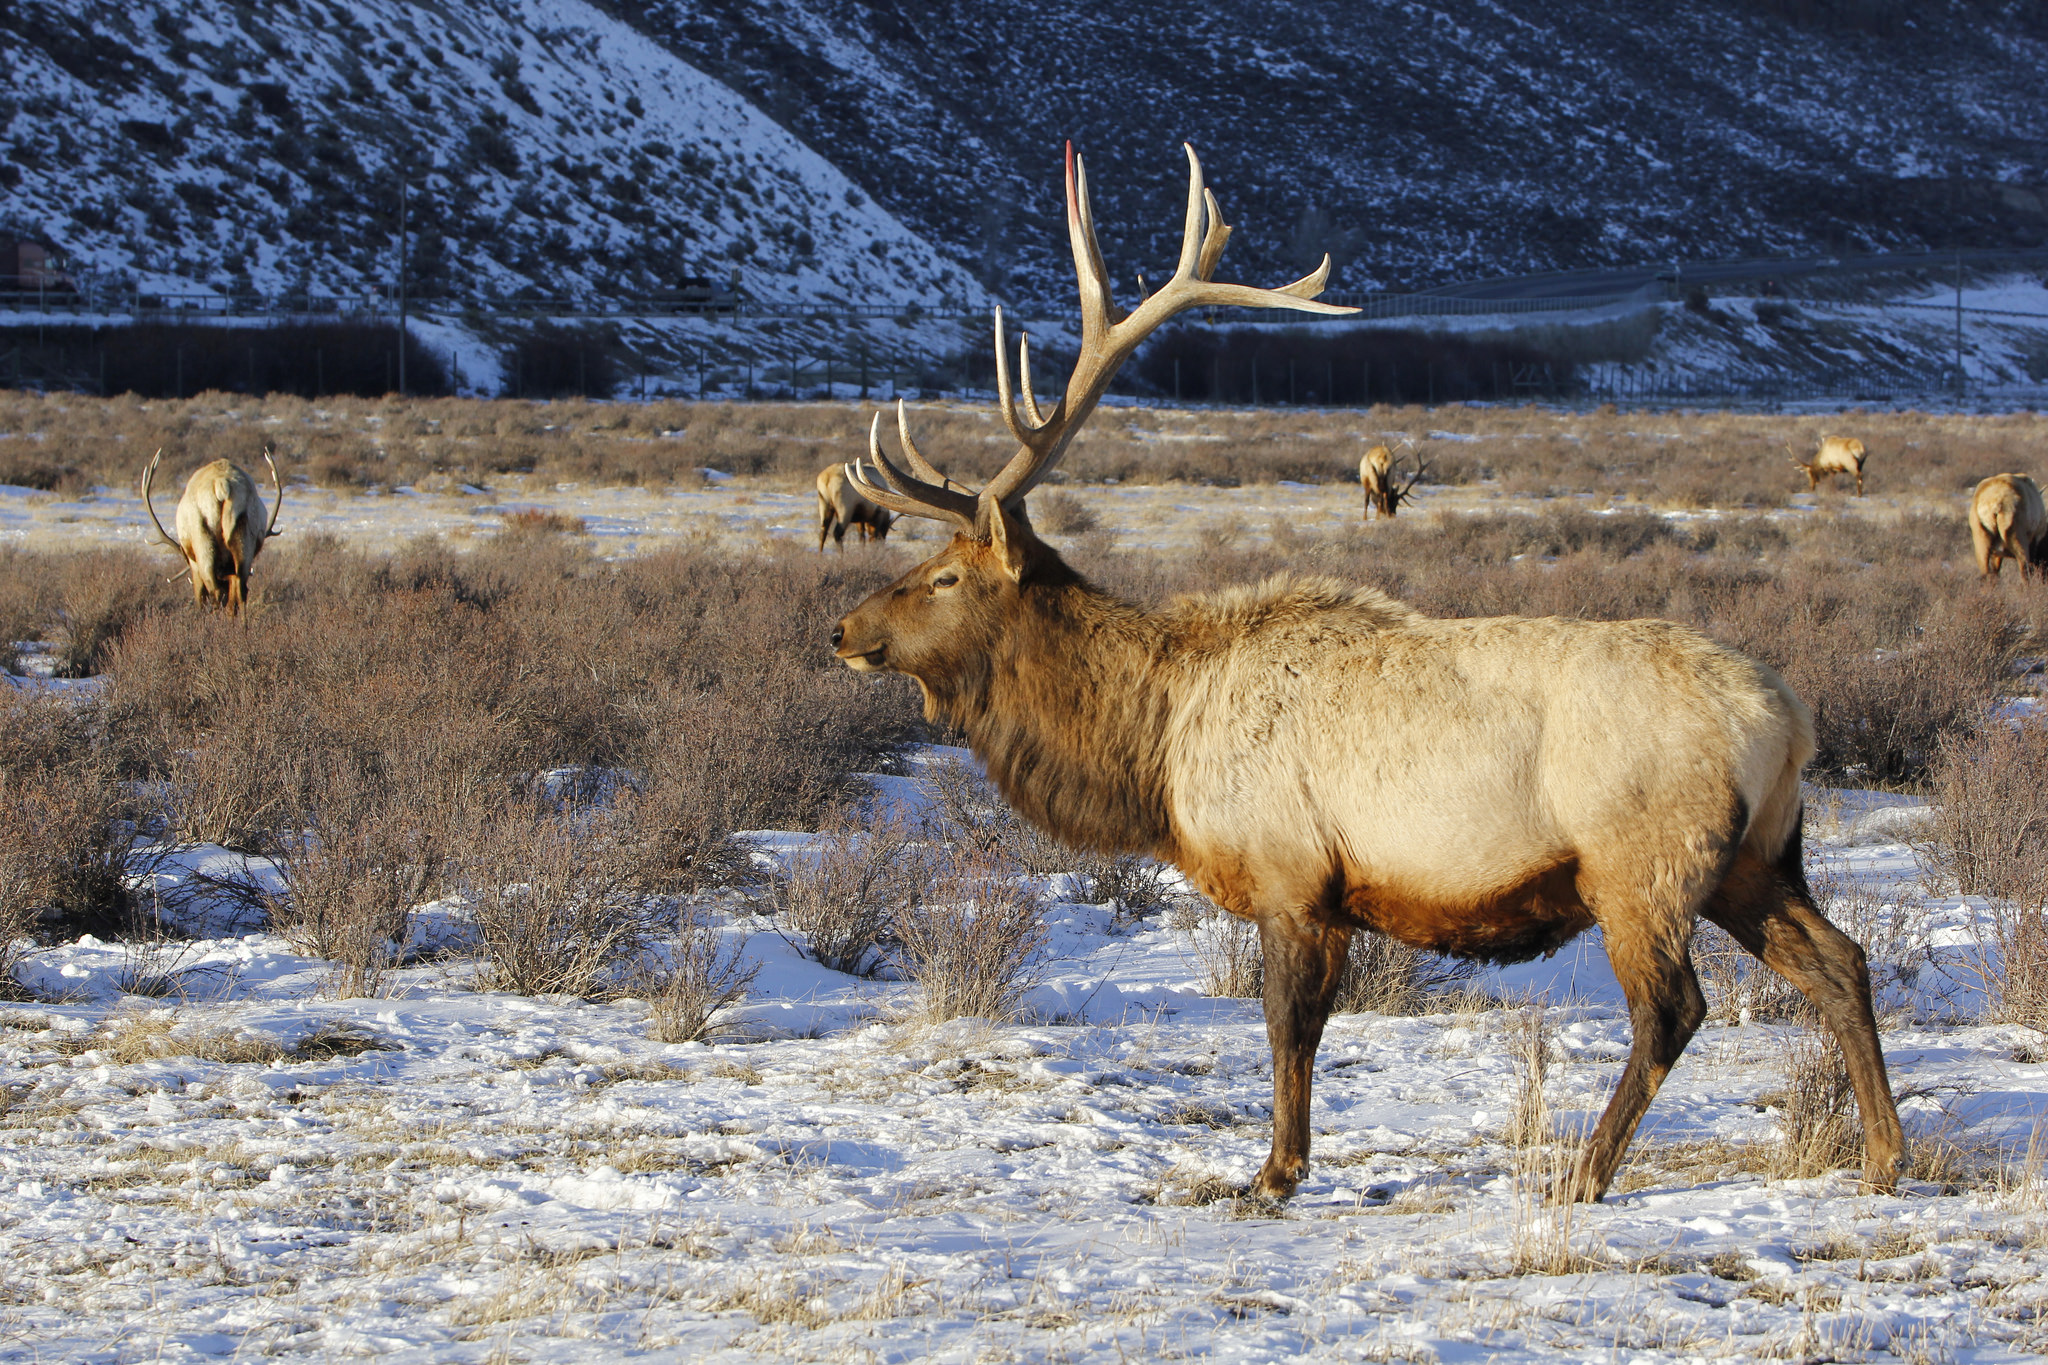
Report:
831,143,1903,1199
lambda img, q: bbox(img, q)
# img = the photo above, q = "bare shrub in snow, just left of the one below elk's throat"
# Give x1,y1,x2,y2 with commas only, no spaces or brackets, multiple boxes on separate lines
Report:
770,806,930,976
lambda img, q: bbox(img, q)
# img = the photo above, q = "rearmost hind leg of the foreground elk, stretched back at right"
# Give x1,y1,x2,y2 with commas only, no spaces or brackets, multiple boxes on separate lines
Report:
1700,839,1907,1193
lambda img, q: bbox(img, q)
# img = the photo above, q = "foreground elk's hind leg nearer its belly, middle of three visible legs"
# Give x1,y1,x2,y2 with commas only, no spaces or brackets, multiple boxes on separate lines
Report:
1552,913,1706,1203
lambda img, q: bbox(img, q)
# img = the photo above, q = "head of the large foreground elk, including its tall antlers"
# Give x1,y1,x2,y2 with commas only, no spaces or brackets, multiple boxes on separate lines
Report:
831,143,1358,716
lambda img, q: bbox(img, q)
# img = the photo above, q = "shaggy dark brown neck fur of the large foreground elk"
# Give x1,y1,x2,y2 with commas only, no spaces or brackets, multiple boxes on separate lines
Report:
926,544,1176,857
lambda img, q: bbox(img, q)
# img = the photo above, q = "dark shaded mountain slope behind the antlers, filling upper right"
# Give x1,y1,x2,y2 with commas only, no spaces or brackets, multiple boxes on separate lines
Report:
614,0,2048,301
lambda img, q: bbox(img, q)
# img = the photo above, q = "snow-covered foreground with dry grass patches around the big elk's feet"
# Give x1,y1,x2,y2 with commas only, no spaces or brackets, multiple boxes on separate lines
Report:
0,755,2048,1361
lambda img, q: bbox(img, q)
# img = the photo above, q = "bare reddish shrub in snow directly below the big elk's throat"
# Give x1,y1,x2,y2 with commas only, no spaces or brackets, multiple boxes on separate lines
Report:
893,849,1047,1023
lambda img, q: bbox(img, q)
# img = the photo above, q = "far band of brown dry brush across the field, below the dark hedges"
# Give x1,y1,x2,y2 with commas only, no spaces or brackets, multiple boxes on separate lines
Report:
0,393,2044,507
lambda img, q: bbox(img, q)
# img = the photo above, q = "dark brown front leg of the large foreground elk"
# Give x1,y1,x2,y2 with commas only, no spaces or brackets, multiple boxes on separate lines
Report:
1251,919,1352,1199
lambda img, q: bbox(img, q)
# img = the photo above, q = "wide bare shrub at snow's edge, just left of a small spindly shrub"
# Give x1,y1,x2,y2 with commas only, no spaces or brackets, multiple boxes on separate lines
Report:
457,800,653,997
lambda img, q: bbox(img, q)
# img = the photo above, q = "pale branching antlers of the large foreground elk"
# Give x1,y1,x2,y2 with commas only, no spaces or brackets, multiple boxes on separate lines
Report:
846,141,1358,538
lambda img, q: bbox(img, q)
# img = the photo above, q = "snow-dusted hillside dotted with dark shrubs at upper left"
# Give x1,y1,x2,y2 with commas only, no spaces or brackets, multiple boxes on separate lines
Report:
0,0,979,303
